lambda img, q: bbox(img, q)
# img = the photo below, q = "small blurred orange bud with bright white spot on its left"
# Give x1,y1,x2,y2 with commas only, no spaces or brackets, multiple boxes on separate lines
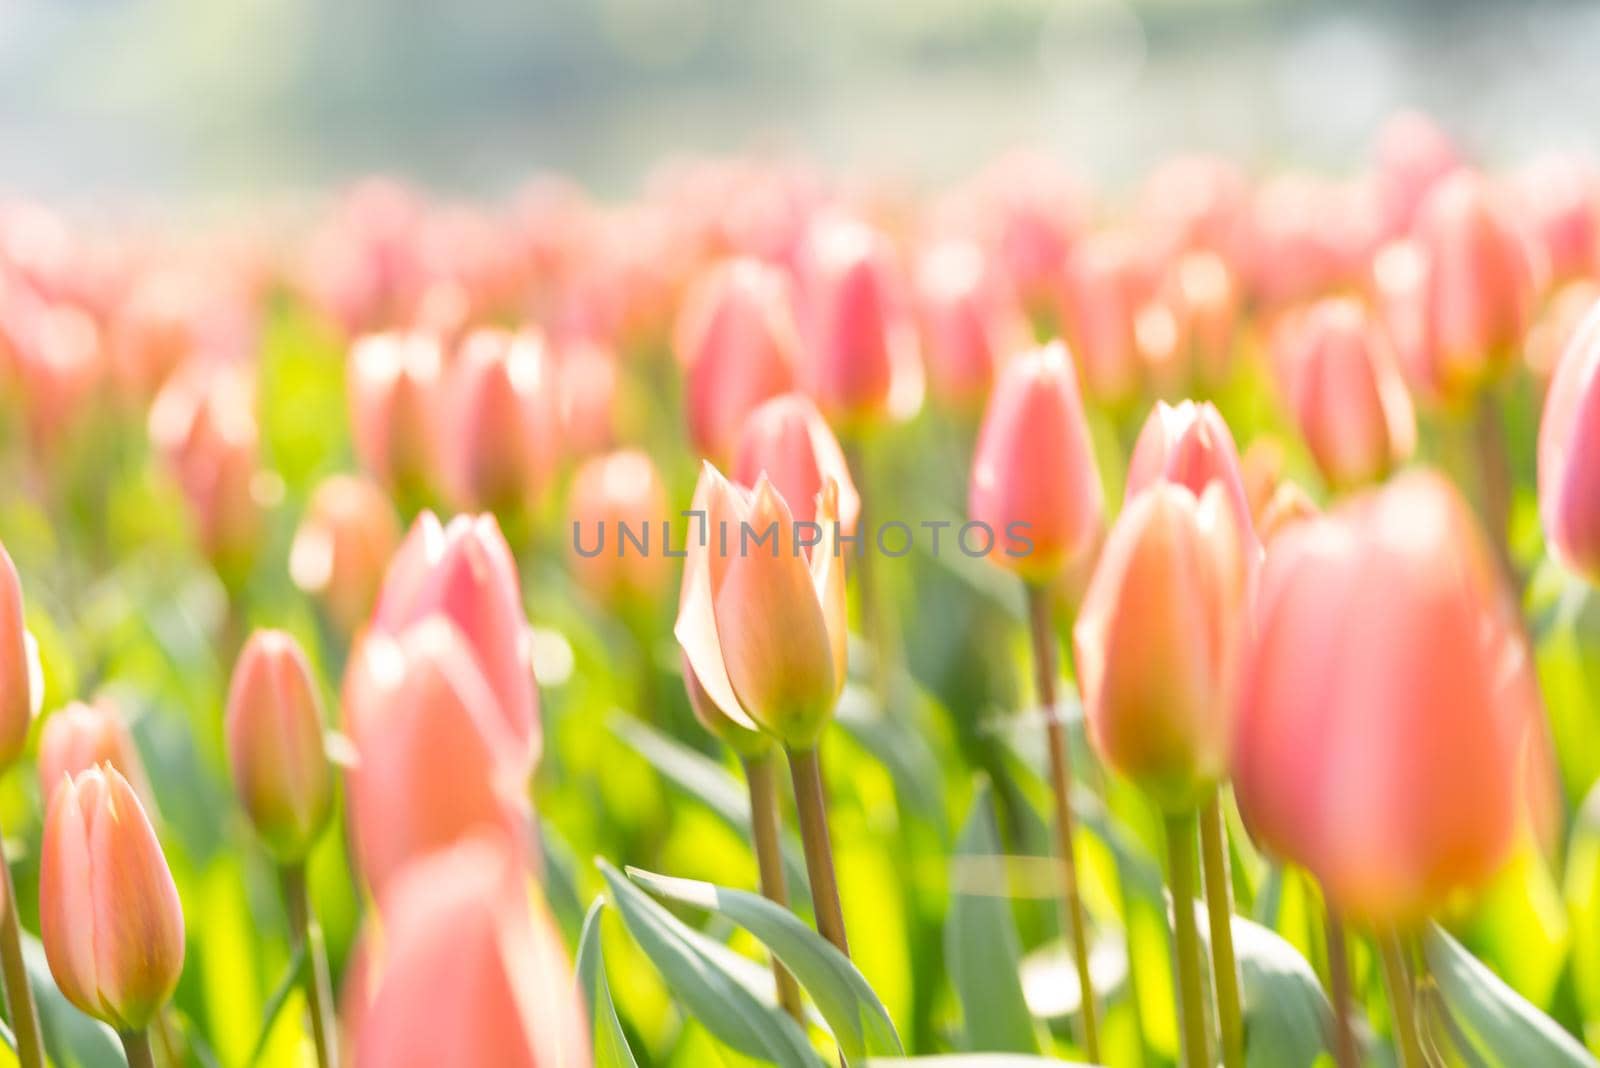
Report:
290,475,400,635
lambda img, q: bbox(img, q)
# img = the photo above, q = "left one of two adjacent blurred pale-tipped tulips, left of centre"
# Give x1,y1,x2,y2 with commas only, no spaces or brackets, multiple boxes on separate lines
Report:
346,333,445,492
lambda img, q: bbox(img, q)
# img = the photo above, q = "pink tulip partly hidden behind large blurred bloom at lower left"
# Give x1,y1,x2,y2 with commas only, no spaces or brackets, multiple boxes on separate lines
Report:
371,512,539,772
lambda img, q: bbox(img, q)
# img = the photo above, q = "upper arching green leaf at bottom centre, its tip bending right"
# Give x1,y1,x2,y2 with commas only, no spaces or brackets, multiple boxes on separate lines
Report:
627,868,904,1062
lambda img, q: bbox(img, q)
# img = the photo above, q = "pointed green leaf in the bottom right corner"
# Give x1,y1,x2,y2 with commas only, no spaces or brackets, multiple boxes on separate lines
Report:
1424,927,1600,1068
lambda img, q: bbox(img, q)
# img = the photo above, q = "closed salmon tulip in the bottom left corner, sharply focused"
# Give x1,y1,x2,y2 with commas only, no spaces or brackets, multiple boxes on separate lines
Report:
38,766,184,1031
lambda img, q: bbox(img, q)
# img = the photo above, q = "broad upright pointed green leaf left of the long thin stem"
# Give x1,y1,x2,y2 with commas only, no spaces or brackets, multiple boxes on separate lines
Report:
944,782,1040,1054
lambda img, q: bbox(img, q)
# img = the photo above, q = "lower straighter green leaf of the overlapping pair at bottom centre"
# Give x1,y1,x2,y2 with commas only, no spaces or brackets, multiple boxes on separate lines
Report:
595,860,819,1068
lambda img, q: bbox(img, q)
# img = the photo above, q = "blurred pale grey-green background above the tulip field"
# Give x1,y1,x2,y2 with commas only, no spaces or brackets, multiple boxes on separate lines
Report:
0,0,1600,205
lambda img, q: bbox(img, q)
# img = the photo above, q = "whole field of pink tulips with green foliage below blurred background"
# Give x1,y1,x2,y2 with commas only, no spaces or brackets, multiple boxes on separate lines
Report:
0,114,1600,1068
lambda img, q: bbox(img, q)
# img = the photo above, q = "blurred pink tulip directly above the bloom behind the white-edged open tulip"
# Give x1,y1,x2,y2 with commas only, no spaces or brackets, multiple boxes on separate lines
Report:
674,259,800,460
